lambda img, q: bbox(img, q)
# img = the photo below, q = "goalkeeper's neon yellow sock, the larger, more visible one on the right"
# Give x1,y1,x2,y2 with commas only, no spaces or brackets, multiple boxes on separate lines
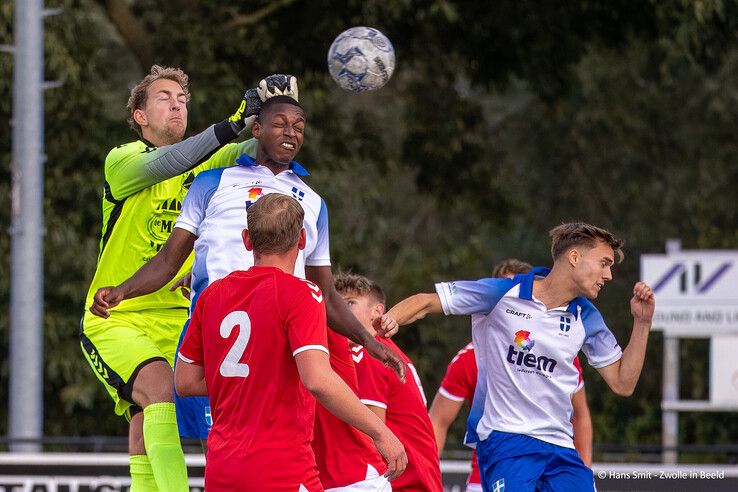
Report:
143,403,190,492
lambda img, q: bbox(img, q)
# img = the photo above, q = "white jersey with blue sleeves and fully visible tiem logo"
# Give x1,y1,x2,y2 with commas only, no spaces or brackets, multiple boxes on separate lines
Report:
436,268,622,448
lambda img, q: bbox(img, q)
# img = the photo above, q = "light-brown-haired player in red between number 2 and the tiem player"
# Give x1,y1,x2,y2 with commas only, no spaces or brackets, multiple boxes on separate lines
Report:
336,274,443,492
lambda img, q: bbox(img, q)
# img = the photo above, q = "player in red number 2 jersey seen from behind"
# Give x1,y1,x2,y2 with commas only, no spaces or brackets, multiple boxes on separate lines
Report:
175,193,407,492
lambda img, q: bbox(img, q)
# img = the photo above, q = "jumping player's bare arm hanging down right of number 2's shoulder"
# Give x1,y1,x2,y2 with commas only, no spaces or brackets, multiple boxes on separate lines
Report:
305,266,407,382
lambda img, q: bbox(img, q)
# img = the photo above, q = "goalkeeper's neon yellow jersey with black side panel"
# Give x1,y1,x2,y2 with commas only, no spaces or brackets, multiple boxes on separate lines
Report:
85,139,256,311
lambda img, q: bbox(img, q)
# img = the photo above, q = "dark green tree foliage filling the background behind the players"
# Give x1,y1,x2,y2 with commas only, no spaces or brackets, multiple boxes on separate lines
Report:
0,0,738,458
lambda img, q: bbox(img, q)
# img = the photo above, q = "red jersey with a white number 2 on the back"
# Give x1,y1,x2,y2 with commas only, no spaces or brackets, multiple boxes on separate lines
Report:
179,266,328,492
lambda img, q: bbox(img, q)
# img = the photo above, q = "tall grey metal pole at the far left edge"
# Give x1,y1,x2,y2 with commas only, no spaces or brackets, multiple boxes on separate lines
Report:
8,0,44,452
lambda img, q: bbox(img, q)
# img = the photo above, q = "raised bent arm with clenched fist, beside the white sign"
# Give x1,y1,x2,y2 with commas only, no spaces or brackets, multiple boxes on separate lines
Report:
597,282,656,396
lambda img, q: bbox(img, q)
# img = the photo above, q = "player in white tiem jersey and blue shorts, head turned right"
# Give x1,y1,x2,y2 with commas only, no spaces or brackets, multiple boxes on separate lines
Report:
388,223,655,492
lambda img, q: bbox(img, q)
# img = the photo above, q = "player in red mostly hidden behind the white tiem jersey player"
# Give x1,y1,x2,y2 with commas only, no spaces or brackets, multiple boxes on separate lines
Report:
428,258,592,492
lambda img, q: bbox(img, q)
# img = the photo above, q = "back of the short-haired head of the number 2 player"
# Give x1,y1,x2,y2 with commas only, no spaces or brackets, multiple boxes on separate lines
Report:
246,193,305,256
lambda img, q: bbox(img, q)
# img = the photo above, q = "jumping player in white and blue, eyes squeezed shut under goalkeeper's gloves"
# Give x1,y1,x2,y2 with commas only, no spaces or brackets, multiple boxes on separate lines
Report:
90,96,405,440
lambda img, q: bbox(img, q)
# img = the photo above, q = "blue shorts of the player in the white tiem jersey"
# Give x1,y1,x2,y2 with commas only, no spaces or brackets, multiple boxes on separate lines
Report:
477,431,595,492
